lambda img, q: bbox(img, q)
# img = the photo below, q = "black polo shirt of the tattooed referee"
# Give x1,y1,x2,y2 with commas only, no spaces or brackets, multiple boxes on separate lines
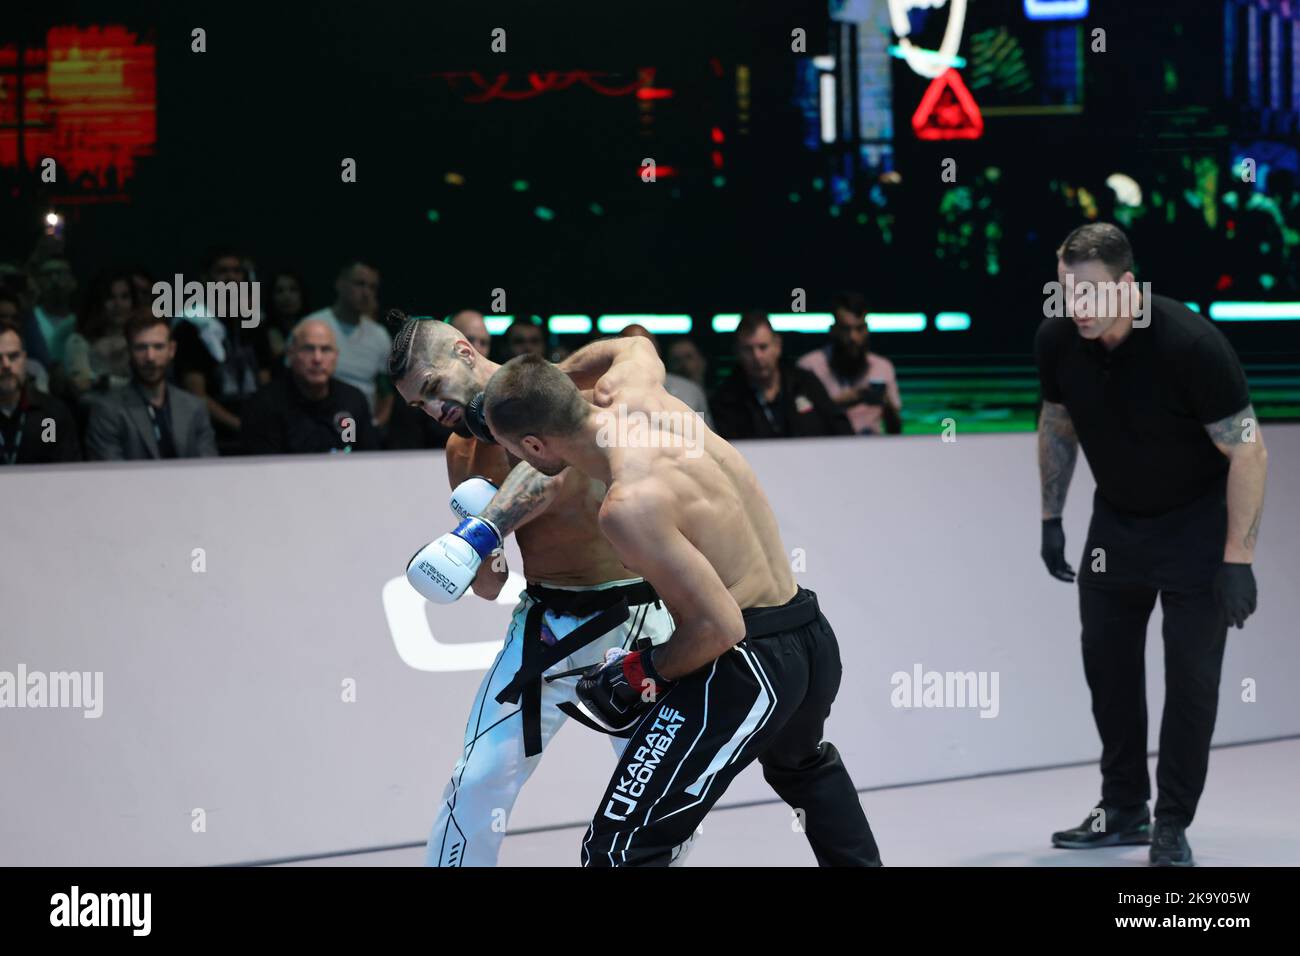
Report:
1035,295,1251,587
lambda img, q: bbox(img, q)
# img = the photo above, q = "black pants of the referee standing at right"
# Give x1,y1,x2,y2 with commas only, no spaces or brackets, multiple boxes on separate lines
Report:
1079,584,1227,826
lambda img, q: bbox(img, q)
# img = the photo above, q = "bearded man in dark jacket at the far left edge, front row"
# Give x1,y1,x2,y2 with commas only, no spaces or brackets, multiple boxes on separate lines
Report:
0,319,81,464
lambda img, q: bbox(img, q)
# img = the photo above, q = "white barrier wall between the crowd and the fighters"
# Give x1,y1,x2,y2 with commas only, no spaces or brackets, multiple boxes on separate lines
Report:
0,425,1300,865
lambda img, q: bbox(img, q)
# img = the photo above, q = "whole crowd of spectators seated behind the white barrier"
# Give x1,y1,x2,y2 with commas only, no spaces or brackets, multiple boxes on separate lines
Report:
0,247,902,464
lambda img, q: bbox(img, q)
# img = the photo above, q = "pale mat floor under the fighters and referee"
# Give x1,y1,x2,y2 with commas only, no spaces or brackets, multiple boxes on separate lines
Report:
279,740,1300,866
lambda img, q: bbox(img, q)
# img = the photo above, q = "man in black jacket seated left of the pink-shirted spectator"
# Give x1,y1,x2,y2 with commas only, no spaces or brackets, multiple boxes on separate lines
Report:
711,312,853,438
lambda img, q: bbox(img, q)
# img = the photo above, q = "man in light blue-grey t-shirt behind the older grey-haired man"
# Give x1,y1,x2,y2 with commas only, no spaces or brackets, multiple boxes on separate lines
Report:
299,259,393,428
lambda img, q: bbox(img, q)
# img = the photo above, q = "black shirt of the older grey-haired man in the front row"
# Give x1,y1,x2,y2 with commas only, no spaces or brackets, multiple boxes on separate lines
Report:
242,378,380,455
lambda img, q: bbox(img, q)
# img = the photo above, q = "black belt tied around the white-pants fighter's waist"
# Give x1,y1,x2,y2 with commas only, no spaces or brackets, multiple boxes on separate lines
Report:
497,581,659,757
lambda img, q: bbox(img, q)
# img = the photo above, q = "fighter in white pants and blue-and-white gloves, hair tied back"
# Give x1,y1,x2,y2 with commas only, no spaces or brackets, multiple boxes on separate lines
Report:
389,312,684,866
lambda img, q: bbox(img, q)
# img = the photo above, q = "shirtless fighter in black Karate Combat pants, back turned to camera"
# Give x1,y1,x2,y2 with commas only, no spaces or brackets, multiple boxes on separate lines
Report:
485,338,880,866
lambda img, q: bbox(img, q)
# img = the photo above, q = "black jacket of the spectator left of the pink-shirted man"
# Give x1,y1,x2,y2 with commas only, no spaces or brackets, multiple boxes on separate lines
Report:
709,365,853,438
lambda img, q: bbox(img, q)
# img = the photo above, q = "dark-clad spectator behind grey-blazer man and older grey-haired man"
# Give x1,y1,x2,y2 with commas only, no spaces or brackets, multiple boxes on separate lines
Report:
172,247,270,454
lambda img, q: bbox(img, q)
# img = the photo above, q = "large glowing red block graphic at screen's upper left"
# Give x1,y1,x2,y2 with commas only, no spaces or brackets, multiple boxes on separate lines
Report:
0,26,157,202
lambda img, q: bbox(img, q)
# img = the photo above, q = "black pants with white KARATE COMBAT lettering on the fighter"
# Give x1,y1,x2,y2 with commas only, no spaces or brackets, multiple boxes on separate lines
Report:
581,588,880,866
